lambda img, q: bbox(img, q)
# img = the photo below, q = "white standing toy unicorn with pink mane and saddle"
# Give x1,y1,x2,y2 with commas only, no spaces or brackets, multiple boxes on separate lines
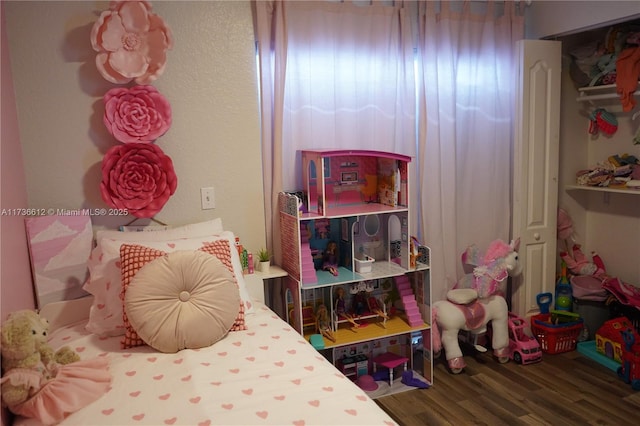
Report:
431,239,522,374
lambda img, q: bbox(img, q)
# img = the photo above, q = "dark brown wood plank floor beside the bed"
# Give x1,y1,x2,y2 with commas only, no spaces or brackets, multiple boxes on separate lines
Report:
376,351,640,426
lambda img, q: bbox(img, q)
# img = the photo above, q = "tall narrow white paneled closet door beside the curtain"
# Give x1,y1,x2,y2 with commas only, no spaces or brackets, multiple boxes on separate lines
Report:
511,40,561,317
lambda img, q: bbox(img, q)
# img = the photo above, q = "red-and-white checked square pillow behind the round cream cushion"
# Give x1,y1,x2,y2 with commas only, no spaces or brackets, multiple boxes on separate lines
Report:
120,240,247,349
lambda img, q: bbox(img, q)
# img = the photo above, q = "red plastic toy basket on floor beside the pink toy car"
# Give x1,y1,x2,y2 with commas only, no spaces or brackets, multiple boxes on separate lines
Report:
531,314,583,354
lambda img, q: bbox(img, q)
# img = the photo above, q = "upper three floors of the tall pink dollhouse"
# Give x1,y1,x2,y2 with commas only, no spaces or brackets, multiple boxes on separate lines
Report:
278,150,433,392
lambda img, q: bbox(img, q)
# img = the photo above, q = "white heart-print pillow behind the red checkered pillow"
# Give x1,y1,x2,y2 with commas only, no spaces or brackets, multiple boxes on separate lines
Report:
83,220,253,336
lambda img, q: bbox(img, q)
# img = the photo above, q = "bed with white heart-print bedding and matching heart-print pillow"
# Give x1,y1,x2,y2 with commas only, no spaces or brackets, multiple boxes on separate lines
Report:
14,218,396,425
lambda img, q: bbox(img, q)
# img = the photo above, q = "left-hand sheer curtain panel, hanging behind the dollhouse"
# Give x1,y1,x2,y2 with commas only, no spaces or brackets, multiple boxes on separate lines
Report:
253,1,416,260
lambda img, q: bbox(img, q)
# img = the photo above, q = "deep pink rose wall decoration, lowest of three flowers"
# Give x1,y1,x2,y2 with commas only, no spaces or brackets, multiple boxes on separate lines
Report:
100,143,178,217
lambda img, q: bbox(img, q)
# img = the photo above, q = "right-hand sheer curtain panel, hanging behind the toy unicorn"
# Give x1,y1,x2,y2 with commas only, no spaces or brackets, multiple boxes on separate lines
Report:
417,1,524,300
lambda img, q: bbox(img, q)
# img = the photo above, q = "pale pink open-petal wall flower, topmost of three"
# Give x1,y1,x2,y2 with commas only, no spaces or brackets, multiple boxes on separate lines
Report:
91,1,173,84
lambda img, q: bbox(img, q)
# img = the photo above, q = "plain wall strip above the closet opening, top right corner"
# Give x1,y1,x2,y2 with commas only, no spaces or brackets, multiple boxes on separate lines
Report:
525,0,640,39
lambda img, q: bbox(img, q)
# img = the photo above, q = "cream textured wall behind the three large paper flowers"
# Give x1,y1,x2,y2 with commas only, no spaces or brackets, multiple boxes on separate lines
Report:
3,1,265,251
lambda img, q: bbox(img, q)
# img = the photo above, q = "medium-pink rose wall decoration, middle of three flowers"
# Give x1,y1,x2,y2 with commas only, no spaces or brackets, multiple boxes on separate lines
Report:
103,86,171,143
